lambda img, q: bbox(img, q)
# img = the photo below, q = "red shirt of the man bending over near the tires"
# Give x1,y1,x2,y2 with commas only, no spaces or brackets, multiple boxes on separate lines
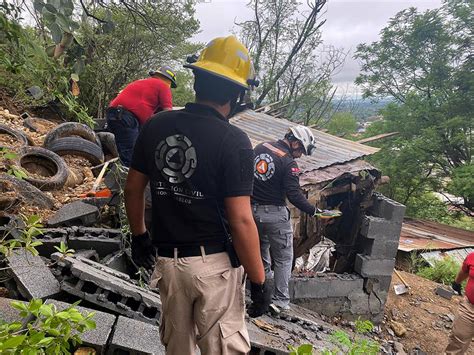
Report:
109,78,173,124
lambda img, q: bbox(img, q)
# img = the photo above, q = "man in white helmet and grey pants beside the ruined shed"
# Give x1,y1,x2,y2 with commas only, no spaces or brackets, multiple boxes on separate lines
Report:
252,126,319,313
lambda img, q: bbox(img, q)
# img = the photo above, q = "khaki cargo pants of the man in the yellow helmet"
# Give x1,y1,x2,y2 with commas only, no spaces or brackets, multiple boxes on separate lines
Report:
151,252,250,355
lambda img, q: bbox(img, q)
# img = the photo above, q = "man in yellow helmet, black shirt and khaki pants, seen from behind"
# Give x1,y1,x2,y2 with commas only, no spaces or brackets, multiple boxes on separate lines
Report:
125,36,270,355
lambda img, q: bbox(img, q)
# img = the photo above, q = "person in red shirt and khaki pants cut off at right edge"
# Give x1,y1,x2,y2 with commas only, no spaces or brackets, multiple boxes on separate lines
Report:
445,253,474,354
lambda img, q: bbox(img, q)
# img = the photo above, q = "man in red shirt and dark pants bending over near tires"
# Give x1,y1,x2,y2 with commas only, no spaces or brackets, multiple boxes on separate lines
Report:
106,66,177,167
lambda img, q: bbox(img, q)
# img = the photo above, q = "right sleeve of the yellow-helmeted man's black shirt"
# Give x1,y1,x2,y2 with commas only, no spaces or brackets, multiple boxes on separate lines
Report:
221,130,254,197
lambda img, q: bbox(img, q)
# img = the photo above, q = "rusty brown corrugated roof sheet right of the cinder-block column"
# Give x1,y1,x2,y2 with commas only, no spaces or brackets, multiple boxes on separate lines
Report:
398,218,474,252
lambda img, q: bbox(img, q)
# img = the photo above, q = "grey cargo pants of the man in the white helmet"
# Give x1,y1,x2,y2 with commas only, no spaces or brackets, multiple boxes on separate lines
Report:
252,205,293,309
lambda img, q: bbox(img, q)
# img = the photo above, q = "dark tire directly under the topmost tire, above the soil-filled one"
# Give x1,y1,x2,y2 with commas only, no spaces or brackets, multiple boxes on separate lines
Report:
48,137,104,165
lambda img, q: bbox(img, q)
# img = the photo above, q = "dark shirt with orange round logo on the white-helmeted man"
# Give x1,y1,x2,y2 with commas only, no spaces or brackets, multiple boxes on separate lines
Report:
252,140,315,215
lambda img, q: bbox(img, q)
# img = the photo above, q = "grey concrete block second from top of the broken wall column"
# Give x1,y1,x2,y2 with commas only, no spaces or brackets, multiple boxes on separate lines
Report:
360,216,402,242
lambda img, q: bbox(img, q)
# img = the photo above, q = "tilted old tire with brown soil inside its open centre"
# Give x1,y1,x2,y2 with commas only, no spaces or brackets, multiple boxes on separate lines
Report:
16,147,68,191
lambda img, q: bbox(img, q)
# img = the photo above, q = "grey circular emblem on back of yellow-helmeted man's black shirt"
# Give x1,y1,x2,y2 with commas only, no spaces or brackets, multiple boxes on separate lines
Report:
155,134,197,184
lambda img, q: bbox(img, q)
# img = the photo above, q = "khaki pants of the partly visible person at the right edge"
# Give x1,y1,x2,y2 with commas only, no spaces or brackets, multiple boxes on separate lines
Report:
445,297,474,355
